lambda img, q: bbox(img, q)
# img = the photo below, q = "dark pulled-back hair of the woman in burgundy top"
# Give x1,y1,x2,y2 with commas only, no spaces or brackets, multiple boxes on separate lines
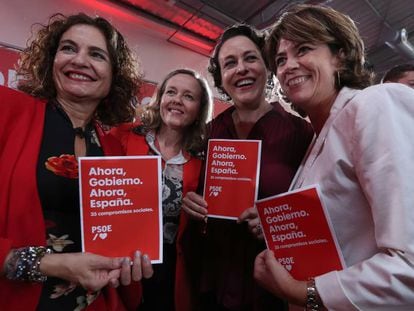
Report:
207,24,267,98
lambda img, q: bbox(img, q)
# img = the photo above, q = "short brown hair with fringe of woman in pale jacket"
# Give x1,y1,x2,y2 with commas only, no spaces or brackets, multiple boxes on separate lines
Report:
265,5,373,90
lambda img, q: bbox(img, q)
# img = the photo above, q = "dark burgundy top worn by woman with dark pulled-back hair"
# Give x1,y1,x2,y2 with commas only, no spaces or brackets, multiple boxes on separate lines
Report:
199,103,313,311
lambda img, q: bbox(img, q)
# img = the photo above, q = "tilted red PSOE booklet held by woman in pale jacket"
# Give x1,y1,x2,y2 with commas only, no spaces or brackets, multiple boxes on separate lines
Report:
256,185,345,280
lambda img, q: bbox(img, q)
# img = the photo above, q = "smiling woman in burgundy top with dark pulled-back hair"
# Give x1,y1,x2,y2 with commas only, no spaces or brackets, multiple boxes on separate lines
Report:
183,25,313,311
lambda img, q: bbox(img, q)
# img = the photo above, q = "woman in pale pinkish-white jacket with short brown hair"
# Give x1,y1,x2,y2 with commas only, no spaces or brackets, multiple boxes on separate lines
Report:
255,5,414,310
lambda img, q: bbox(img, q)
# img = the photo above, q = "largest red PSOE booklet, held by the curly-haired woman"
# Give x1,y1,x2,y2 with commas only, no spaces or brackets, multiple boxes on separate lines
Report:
79,156,162,263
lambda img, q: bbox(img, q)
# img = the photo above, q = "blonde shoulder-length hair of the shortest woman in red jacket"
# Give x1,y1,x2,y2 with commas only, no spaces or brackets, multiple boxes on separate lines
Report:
138,69,212,156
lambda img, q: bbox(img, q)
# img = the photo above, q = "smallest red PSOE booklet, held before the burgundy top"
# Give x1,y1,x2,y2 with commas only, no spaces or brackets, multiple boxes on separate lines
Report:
204,139,262,219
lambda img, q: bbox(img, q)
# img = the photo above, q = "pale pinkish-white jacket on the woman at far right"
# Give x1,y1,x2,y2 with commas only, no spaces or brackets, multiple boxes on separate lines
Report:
291,83,414,311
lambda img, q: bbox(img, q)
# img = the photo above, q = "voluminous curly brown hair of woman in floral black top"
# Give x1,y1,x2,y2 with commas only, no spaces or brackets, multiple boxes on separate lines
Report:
17,13,142,125
